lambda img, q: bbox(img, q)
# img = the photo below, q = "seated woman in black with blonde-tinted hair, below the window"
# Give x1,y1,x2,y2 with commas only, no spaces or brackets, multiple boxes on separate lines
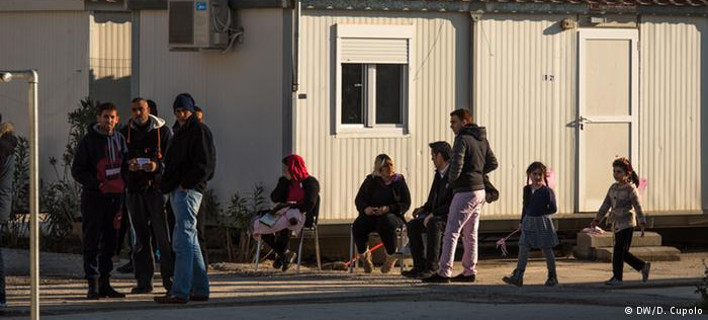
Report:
352,154,411,273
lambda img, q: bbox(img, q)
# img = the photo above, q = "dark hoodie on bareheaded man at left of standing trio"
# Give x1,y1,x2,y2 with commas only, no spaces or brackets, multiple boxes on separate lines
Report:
71,123,128,192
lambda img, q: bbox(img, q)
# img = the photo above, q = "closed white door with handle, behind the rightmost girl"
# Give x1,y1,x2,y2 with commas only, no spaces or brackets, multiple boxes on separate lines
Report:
576,29,639,212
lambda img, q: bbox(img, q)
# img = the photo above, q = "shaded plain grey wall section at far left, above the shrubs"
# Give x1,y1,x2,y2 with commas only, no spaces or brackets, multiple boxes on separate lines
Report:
0,11,89,180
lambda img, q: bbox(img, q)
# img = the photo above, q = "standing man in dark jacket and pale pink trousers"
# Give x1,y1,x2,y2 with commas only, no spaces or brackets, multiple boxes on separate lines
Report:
423,109,498,282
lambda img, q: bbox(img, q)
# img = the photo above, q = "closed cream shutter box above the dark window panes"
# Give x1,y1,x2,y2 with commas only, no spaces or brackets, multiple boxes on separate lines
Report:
340,38,408,64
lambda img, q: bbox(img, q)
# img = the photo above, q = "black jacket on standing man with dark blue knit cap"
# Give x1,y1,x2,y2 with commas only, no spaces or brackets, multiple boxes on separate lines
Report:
160,115,216,193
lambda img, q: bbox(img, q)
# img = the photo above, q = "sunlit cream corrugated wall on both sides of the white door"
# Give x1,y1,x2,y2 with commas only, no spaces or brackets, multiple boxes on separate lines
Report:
474,15,708,217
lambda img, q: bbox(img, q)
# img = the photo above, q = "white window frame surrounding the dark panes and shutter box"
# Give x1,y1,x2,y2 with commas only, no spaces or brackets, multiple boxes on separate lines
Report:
334,24,415,138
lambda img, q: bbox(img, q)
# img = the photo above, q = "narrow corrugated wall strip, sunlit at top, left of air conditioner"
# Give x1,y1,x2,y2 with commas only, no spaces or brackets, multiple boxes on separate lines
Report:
89,12,132,112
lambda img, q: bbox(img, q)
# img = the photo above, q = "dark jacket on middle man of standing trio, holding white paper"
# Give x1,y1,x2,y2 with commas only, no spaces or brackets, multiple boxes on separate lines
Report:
121,115,172,193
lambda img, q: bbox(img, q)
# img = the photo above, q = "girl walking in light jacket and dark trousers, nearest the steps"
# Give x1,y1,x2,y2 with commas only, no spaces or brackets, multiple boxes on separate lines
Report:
590,158,651,286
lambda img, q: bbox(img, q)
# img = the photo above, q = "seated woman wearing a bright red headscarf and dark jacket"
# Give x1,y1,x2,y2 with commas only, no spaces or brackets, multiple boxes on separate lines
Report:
253,154,320,271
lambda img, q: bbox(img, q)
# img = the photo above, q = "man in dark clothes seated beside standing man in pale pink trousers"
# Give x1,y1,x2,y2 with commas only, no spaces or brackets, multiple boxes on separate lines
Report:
402,141,452,278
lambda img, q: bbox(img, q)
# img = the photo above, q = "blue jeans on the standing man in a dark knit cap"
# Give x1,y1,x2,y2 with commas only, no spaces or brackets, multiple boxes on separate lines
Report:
170,189,209,300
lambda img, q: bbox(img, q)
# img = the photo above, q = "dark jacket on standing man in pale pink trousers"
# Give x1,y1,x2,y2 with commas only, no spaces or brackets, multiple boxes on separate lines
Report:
448,124,498,193
